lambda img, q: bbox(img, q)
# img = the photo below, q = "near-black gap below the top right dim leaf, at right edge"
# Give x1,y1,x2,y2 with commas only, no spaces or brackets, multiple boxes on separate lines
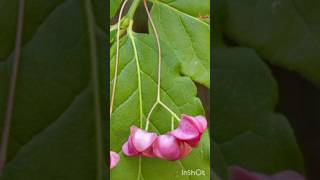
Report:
270,65,320,180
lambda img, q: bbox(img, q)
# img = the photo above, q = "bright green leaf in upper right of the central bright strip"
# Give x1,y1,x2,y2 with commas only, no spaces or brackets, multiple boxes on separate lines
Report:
150,0,210,87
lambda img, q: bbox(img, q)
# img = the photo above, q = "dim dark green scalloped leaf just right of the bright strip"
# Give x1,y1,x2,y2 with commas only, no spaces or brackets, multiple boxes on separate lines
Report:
214,48,304,179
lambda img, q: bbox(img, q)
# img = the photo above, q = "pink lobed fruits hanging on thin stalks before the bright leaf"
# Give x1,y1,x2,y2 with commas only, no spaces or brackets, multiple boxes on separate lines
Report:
110,115,207,168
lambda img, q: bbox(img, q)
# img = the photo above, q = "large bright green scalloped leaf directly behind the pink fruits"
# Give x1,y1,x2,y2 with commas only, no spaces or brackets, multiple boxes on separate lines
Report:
110,33,210,180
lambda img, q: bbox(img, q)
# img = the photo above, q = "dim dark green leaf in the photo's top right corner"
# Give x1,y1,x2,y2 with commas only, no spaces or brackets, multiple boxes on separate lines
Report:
221,0,320,87
